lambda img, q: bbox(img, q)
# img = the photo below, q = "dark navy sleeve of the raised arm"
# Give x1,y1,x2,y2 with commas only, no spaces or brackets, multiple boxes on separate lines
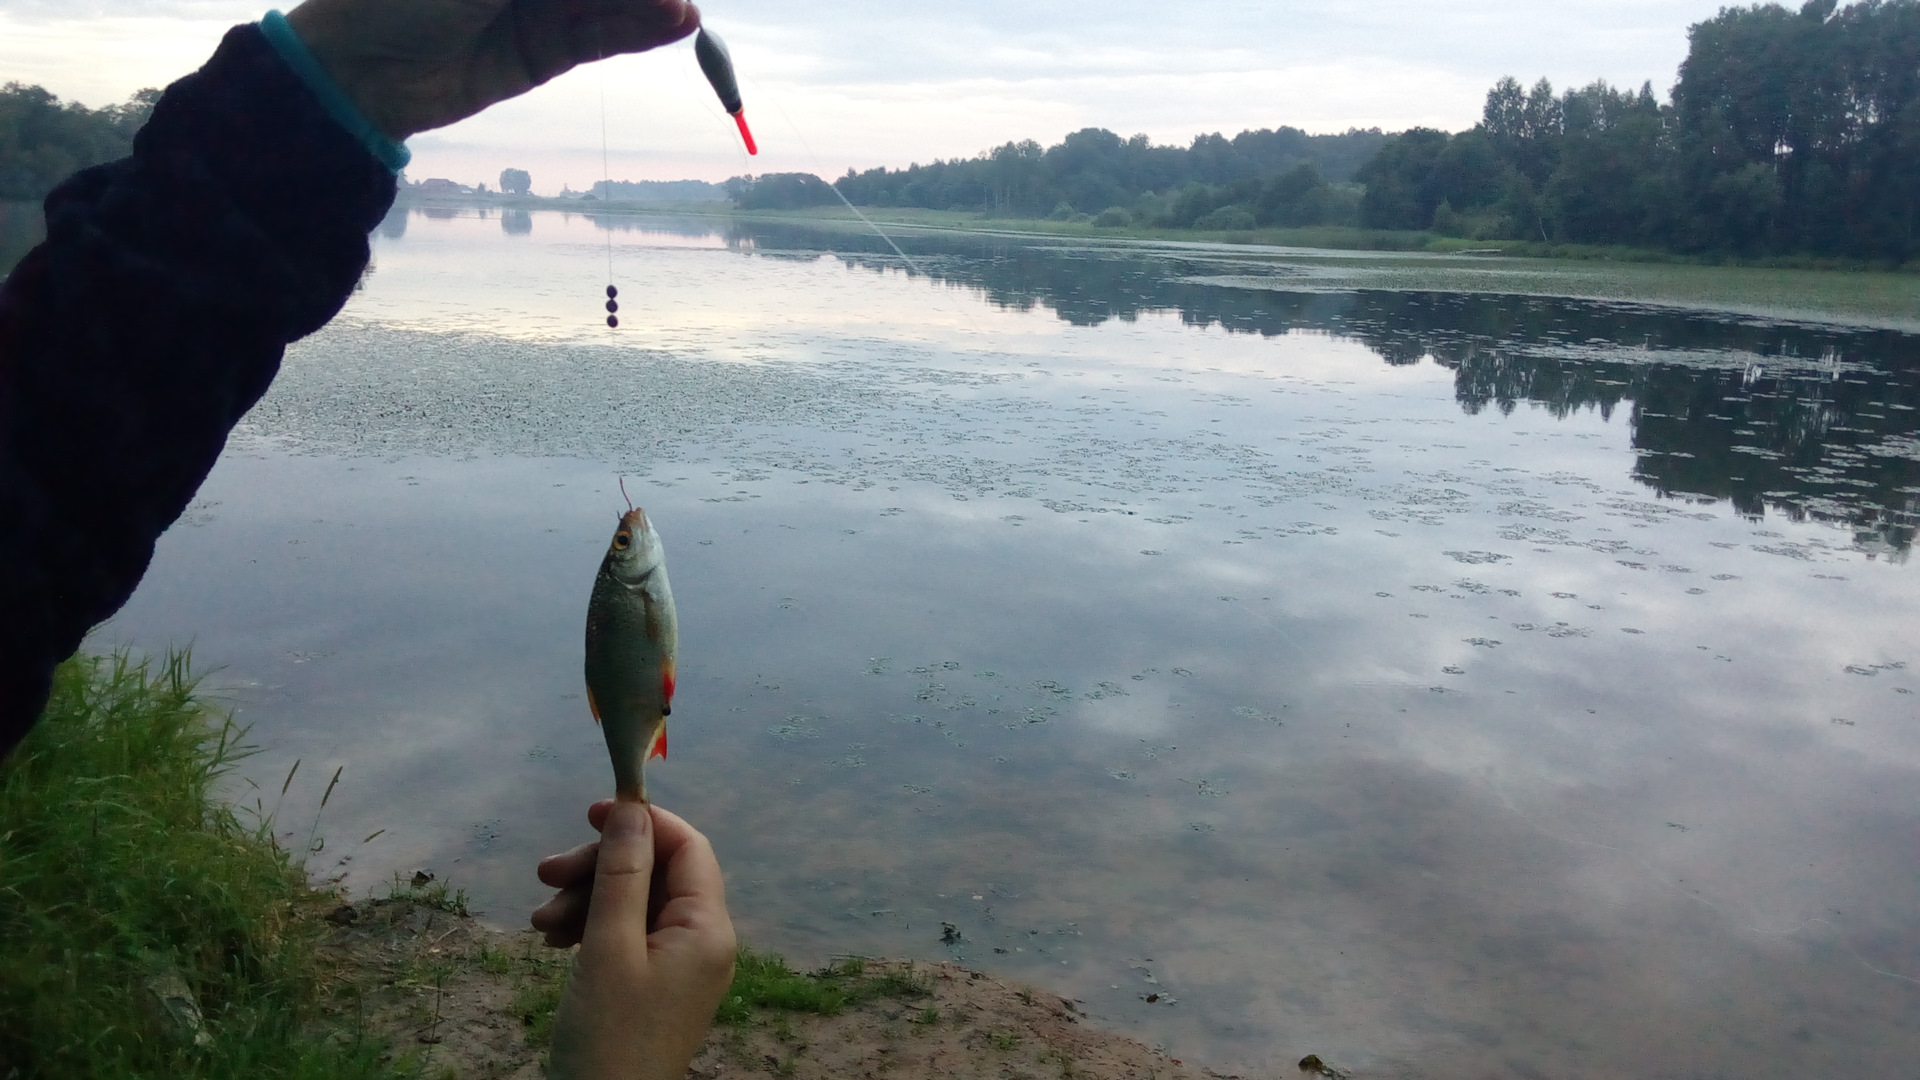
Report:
0,25,394,753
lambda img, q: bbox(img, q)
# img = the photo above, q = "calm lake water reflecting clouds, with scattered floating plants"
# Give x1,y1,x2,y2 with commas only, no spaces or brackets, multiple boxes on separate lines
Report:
15,211,1920,1078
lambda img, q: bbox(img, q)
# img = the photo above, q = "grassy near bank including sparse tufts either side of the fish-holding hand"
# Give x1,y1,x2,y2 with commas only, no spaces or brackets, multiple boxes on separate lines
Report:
0,657,960,1080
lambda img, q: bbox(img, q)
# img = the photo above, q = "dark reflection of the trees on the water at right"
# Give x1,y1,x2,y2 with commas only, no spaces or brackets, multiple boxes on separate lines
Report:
726,225,1920,555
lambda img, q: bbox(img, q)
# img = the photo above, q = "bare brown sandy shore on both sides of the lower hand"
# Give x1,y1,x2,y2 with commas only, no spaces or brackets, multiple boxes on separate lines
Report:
321,899,1290,1080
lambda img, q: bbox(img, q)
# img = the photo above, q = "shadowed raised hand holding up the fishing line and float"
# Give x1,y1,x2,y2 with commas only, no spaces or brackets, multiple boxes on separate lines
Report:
286,0,701,140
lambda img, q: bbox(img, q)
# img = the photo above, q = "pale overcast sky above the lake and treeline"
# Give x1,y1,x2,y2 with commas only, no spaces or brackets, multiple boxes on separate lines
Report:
0,0,1720,194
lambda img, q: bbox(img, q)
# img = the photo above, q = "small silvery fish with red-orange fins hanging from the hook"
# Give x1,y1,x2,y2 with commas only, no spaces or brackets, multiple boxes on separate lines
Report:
586,484,680,803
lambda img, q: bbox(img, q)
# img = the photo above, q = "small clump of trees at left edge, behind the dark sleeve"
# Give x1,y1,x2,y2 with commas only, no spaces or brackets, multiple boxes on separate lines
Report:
0,83,159,200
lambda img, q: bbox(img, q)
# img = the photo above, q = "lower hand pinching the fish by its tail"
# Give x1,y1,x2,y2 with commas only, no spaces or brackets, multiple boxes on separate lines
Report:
534,799,737,1080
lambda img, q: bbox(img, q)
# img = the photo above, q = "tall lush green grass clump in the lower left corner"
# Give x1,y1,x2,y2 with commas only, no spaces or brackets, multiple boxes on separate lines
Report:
0,657,413,1080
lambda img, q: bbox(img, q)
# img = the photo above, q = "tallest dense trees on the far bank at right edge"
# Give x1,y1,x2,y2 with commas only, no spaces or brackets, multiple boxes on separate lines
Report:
1357,0,1920,261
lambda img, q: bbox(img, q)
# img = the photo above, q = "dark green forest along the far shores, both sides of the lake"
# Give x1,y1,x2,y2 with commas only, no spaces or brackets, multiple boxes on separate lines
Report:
0,0,1920,265
